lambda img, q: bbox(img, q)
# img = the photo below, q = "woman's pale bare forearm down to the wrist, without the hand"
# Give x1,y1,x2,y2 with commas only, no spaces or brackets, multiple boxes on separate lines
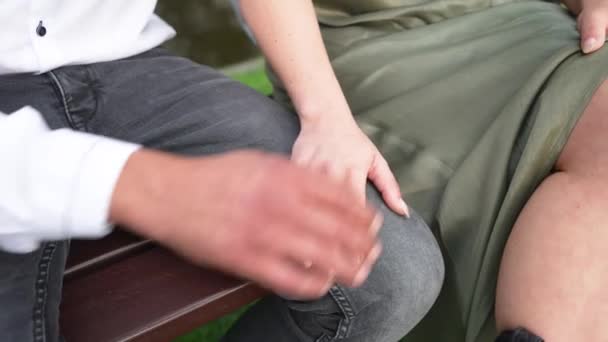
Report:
240,0,350,122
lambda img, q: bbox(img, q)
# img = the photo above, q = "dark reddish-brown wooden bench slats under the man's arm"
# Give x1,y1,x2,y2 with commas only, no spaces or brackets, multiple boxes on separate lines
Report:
61,230,265,342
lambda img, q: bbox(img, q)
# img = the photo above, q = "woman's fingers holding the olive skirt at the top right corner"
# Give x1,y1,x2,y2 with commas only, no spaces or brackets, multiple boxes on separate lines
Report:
564,0,608,53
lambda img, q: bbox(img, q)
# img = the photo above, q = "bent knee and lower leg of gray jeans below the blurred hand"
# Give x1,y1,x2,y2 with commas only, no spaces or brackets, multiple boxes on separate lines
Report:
223,186,444,342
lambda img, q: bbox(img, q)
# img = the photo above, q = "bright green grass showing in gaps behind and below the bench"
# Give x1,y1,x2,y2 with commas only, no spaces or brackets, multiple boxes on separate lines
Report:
174,67,272,342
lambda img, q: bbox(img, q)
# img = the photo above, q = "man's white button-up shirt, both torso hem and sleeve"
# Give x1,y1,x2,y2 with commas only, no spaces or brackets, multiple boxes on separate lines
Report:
0,0,175,252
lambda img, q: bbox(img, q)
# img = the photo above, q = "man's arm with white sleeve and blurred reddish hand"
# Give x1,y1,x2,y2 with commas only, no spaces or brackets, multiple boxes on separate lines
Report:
0,108,380,298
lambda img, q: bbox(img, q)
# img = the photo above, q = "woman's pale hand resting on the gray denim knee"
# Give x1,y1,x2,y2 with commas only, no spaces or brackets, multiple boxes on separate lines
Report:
292,113,409,217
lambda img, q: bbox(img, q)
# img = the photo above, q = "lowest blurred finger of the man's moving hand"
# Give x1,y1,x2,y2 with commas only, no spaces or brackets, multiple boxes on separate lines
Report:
241,254,333,300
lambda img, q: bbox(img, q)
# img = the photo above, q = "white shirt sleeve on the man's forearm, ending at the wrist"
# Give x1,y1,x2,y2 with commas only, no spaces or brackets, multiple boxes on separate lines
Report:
0,107,139,253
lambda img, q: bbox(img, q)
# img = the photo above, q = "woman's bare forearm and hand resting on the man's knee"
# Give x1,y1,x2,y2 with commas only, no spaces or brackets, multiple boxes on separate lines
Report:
239,0,408,215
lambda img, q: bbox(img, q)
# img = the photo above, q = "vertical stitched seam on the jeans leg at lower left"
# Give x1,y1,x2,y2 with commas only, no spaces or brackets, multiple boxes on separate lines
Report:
33,242,57,342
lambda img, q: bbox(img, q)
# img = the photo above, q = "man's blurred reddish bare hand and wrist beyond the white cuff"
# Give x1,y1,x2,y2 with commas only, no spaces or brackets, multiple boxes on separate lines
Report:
110,150,381,299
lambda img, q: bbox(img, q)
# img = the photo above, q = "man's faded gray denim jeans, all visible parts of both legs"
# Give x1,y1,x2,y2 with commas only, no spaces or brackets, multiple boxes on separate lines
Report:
0,49,443,342
